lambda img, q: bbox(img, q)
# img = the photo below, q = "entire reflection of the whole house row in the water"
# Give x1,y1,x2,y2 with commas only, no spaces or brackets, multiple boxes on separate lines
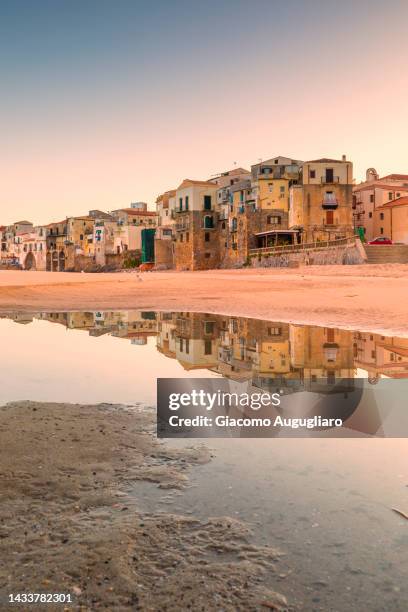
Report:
8,310,408,382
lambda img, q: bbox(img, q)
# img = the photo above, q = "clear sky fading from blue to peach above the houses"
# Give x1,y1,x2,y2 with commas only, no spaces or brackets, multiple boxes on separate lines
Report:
0,0,408,224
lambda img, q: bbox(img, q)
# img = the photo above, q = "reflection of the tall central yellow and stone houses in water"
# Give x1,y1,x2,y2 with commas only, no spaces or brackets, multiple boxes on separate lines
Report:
157,313,354,388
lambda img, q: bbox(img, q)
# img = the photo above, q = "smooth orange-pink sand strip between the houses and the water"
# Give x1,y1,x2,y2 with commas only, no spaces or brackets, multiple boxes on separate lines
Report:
0,264,408,336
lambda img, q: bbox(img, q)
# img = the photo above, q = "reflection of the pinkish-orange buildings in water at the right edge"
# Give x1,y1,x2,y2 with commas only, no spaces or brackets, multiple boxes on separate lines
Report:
353,332,408,382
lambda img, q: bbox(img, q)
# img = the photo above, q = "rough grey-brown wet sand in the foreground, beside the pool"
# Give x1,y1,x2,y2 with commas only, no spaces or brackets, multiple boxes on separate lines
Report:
0,401,292,612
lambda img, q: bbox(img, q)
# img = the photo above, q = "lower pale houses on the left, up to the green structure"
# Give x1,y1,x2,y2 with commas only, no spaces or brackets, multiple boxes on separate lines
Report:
0,202,157,272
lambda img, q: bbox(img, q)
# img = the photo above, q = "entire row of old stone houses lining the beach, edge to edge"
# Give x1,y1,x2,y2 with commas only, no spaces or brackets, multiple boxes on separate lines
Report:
0,155,408,271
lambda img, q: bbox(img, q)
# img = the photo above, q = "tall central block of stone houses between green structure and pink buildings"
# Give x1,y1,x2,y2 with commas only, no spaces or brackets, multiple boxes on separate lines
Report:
155,156,354,270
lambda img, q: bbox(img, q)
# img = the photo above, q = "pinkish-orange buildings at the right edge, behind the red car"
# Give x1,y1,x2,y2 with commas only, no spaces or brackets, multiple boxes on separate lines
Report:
353,168,408,244
